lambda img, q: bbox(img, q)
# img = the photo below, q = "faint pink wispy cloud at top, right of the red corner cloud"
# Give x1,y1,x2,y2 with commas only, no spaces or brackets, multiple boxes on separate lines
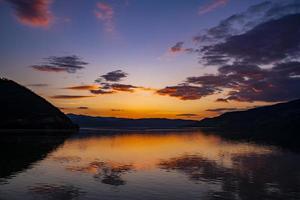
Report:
95,2,115,33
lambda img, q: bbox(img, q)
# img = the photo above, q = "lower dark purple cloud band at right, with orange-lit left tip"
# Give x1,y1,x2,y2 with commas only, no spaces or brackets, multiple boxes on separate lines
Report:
157,62,300,102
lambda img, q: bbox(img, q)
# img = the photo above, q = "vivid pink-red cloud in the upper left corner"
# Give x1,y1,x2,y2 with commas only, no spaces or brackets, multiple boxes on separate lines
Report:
6,0,53,27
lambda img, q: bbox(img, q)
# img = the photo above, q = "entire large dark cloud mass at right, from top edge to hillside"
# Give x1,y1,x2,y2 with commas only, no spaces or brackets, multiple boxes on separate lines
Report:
161,0,300,102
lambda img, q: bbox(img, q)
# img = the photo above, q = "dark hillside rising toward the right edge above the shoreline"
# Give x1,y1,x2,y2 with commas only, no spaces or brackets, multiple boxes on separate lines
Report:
196,99,300,136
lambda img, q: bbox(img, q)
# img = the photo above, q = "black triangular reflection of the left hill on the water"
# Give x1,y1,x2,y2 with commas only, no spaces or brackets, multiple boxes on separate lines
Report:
0,133,68,179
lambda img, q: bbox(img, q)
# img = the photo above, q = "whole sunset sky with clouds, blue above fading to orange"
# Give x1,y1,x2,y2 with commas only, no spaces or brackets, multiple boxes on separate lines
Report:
0,0,300,119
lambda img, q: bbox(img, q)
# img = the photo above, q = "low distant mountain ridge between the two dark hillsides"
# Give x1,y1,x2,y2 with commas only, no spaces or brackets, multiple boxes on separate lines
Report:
67,114,196,129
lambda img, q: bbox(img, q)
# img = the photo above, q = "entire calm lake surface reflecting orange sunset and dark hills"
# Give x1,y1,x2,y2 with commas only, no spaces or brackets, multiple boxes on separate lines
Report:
0,131,300,200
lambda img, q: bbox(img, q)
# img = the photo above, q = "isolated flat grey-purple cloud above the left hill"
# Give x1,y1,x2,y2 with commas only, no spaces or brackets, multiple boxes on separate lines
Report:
30,55,88,73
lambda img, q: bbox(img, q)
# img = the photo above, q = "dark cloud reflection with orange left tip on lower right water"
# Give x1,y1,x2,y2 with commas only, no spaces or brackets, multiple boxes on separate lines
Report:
159,154,300,200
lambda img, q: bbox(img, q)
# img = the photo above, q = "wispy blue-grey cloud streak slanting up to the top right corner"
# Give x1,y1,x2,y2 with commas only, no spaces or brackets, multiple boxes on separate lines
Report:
194,0,300,43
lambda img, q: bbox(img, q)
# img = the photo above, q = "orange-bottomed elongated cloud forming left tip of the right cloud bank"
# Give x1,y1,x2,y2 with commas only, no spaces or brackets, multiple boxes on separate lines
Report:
156,85,216,100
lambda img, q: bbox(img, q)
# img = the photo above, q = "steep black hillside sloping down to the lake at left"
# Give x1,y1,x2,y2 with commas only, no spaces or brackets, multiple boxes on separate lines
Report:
0,78,77,129
